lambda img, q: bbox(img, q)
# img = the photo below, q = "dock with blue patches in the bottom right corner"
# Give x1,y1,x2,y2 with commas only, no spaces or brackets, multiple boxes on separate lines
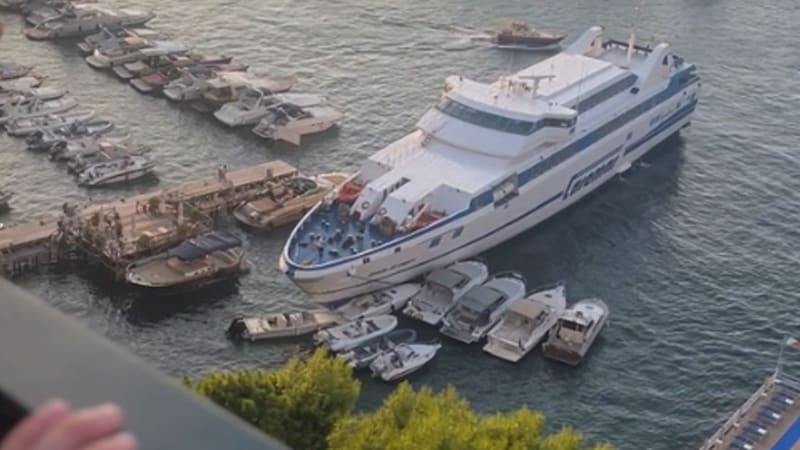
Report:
700,372,800,450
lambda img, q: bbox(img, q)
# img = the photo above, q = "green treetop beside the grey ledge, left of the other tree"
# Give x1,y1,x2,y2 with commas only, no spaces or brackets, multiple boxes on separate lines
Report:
184,350,361,450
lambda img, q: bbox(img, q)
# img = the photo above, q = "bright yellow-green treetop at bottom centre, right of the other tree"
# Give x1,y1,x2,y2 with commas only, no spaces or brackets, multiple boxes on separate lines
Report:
328,383,611,450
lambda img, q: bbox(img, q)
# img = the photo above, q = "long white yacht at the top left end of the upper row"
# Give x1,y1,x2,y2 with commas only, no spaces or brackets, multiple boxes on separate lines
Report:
25,4,155,40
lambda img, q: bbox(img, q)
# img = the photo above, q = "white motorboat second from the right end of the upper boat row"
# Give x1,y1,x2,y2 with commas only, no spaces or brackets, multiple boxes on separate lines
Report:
214,89,326,127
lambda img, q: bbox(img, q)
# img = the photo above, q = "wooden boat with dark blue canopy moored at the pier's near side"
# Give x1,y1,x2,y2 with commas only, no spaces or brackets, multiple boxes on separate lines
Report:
125,231,244,293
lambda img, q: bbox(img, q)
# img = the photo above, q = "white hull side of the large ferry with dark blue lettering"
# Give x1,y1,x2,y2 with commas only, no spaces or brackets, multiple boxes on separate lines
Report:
280,90,697,304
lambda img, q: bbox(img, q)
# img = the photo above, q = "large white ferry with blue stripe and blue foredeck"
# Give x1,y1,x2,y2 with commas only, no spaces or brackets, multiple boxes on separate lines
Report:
280,27,700,303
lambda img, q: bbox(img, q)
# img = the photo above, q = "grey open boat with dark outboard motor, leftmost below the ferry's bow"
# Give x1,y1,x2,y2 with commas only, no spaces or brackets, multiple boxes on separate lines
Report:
225,309,338,342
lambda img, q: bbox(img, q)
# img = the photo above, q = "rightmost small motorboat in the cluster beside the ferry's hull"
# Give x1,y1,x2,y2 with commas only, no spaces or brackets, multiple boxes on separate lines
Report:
542,298,608,366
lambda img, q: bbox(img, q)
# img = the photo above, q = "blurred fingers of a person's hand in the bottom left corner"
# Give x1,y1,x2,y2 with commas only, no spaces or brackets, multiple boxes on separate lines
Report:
0,400,138,450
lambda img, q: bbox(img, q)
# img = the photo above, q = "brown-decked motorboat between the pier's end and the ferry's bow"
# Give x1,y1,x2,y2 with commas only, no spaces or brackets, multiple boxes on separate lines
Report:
233,172,347,231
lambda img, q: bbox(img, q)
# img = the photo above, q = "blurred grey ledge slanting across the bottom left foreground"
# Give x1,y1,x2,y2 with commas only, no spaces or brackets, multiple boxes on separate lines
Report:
0,279,287,450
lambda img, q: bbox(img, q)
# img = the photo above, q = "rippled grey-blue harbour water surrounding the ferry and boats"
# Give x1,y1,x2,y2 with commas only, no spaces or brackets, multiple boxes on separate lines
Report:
0,0,800,450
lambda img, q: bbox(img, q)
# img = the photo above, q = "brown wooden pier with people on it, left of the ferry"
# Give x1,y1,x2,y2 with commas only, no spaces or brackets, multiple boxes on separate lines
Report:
0,161,297,277
